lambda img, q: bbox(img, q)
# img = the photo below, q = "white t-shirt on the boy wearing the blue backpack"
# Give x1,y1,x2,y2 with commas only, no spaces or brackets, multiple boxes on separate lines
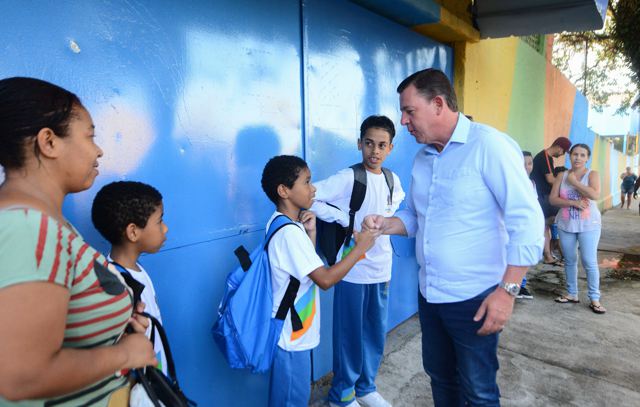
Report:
267,212,324,352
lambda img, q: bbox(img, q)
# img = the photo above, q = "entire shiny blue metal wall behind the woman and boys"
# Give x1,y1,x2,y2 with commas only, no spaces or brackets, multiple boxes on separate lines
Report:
0,0,453,406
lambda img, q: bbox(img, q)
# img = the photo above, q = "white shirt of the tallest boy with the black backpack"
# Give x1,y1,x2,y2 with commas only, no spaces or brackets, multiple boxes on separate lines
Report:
311,168,405,284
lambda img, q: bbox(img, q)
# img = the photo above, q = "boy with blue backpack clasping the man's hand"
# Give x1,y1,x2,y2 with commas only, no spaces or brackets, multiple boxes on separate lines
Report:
262,155,378,407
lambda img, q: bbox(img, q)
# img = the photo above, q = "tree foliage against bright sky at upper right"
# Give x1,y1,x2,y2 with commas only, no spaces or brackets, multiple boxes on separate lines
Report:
553,0,640,112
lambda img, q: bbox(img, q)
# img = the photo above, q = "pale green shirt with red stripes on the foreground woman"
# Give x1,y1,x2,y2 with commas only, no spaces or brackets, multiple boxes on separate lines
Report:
0,208,133,406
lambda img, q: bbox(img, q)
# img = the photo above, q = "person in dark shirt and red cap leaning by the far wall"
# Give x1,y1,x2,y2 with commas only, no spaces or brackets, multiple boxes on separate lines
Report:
530,137,571,264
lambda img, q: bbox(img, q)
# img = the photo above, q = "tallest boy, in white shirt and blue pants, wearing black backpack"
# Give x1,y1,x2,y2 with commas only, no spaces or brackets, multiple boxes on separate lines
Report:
312,116,405,407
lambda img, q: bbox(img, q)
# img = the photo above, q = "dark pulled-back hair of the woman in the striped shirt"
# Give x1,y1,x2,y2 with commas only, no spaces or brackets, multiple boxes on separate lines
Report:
0,77,82,169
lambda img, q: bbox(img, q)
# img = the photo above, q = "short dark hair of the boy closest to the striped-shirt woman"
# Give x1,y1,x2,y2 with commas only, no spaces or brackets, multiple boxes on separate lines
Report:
91,181,162,245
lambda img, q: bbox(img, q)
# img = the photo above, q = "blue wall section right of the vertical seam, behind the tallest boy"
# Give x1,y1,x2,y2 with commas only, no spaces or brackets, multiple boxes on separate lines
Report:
303,1,453,379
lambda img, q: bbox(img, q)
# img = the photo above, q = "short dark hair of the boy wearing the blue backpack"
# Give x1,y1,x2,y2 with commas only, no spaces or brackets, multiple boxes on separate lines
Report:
261,155,309,205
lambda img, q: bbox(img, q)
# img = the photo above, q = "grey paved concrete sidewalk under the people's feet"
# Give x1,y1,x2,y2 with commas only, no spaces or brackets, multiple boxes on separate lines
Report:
311,206,640,407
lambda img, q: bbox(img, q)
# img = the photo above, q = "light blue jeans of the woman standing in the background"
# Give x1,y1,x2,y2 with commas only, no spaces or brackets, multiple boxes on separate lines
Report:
558,229,600,301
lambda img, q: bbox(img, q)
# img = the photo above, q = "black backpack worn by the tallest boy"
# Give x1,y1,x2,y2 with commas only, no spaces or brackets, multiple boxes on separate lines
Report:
316,163,393,266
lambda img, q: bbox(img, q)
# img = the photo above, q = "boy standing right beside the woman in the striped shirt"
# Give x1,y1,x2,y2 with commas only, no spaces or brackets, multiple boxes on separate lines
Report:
91,181,169,375
